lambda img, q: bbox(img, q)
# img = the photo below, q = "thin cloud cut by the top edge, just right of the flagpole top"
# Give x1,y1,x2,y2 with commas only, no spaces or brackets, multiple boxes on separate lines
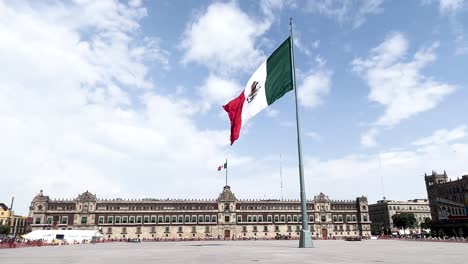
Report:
306,0,384,28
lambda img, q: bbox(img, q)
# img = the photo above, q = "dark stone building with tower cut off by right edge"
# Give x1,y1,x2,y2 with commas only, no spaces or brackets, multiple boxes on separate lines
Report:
424,171,468,237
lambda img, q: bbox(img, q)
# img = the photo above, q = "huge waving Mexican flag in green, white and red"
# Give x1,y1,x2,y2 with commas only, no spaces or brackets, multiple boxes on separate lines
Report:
223,37,293,145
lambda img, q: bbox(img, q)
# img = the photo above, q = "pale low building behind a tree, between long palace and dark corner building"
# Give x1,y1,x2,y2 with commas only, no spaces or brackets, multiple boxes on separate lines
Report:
369,199,431,234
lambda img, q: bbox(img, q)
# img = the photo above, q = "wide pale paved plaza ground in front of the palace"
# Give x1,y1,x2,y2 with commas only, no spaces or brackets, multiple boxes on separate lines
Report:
0,240,468,264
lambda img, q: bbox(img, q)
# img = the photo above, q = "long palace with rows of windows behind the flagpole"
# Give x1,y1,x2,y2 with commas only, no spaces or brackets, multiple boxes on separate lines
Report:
30,186,371,239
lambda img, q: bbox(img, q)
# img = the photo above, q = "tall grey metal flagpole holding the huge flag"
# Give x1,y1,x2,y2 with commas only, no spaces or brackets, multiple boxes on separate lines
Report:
289,17,314,248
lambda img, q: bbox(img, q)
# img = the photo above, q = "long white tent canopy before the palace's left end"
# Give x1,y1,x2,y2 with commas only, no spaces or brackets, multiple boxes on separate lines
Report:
23,230,102,242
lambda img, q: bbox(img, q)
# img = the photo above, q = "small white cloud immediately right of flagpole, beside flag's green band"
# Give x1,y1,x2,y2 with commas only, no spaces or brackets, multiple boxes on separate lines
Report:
297,63,332,108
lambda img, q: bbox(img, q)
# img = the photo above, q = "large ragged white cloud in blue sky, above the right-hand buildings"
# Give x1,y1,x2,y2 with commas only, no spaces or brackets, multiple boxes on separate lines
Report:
352,33,455,127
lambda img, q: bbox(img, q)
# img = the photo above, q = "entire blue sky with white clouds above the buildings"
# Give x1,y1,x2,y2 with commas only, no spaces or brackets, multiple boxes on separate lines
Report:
0,0,468,214
